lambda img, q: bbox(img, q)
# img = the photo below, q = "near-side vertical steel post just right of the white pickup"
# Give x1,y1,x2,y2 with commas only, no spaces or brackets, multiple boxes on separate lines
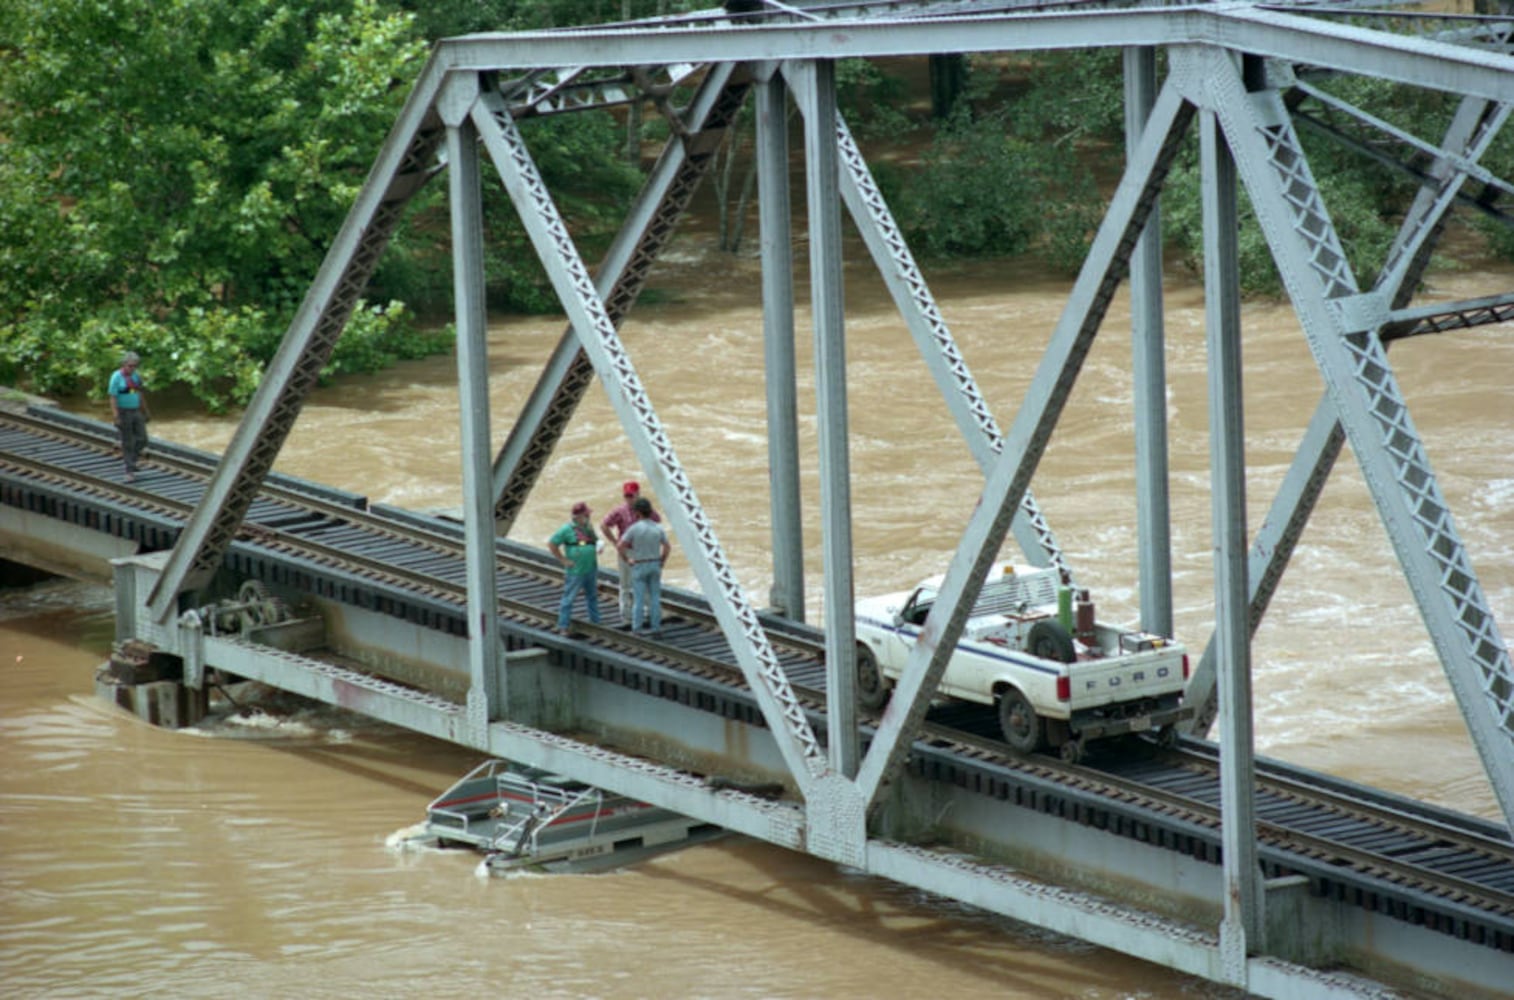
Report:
1199,109,1264,986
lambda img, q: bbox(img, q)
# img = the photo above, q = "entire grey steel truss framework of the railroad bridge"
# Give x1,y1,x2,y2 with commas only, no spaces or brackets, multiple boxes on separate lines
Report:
8,0,1514,997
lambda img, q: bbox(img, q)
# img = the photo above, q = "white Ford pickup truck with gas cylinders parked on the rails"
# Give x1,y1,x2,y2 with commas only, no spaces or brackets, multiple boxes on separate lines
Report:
857,566,1193,761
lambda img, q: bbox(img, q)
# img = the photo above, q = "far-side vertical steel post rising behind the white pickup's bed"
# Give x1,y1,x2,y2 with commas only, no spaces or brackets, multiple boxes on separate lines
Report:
1123,47,1173,637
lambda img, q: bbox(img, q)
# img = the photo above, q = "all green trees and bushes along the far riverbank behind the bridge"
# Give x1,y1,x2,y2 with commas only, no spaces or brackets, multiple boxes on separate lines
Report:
0,0,1509,410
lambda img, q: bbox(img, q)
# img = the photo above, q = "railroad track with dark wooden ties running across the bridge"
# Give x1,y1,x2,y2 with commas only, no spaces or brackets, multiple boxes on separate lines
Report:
0,410,1514,931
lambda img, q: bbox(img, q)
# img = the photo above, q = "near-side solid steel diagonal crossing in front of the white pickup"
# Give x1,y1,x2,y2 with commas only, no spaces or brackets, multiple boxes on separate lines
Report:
857,82,1193,808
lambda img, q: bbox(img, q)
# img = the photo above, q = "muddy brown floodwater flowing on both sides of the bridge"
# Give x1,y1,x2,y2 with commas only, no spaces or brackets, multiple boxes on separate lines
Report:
0,237,1514,1000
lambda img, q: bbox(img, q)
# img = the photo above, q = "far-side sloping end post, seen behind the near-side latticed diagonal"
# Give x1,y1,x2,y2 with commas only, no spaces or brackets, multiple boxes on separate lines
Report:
492,64,749,534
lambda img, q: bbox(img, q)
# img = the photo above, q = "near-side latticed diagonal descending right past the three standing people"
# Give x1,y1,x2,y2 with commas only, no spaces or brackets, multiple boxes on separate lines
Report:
472,83,827,799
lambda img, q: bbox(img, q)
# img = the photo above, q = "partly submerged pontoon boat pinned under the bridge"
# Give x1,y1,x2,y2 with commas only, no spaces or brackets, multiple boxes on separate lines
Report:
422,759,724,873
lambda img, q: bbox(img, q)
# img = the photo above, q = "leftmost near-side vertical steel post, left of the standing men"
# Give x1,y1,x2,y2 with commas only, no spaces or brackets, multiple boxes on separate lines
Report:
438,73,506,747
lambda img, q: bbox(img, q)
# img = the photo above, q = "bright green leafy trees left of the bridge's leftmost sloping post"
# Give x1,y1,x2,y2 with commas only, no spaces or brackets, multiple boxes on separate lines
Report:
0,0,439,405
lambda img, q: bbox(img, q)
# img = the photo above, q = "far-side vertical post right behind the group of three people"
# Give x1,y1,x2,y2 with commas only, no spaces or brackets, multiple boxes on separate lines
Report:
755,73,804,622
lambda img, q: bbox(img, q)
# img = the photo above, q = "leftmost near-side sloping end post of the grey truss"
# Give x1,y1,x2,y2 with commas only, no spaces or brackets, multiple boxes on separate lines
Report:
147,56,444,623
